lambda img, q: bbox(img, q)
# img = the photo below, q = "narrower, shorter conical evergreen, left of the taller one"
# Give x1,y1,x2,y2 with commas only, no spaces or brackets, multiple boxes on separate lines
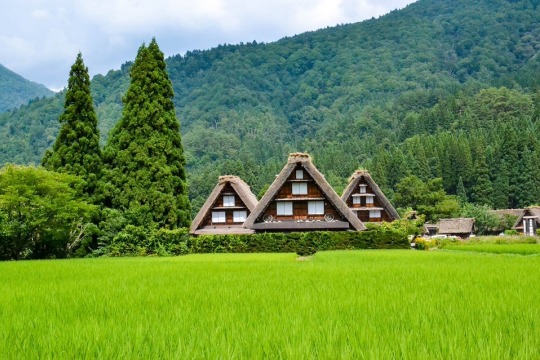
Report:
42,53,102,197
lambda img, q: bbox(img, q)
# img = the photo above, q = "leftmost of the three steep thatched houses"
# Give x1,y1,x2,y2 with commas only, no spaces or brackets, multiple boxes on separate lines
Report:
189,175,257,235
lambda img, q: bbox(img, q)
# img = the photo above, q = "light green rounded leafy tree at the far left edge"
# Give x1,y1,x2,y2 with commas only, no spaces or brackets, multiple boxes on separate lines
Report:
0,165,96,260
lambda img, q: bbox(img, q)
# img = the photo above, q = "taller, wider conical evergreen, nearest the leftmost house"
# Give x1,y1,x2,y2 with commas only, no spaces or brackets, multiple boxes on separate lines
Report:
103,39,191,228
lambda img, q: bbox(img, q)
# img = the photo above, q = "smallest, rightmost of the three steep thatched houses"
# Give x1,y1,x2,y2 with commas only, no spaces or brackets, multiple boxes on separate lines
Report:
341,170,399,222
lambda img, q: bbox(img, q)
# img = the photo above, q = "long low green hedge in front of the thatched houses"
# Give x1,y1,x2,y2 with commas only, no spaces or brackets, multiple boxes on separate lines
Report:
95,225,409,256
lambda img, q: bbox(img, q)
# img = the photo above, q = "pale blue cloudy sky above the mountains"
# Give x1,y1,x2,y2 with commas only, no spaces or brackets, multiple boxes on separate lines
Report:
0,0,414,90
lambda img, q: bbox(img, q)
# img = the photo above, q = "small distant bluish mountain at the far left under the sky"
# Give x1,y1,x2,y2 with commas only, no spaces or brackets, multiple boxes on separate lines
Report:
0,64,54,113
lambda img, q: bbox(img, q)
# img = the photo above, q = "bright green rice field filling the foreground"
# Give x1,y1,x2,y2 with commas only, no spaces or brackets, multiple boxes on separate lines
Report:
0,250,540,359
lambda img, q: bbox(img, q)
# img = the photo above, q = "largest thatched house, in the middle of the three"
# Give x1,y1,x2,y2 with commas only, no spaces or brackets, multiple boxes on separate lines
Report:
244,153,365,232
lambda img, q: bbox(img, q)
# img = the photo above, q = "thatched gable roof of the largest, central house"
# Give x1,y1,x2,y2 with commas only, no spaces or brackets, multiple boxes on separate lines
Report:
244,153,366,231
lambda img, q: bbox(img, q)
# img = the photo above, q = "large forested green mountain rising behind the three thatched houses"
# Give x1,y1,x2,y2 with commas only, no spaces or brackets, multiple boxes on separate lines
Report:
0,0,540,209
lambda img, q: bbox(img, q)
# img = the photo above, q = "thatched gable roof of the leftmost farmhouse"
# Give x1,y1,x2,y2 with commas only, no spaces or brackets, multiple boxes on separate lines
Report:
189,175,257,234
